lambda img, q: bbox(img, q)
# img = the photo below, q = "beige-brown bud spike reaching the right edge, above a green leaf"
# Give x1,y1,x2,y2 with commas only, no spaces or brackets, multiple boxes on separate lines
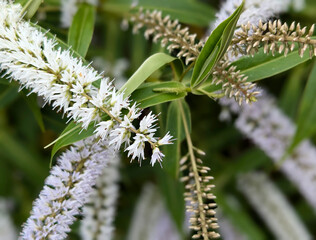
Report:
231,20,316,57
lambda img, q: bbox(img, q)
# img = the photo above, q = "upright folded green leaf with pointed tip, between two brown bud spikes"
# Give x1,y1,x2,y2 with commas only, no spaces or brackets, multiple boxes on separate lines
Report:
191,1,244,88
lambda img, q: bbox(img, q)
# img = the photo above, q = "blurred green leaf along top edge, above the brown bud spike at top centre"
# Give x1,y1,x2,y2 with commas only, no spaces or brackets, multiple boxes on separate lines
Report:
103,0,215,27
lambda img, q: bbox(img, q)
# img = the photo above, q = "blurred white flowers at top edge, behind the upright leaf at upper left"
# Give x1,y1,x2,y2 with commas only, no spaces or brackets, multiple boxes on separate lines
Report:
60,0,98,28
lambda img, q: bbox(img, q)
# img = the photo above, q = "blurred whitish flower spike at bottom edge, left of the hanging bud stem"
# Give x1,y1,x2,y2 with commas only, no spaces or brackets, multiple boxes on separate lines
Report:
127,183,182,240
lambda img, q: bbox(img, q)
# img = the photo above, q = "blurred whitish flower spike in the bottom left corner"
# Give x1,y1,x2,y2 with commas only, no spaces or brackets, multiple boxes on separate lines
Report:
0,197,17,240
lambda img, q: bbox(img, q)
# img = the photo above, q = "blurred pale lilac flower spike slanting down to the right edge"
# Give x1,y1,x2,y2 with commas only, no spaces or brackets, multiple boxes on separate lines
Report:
220,90,316,209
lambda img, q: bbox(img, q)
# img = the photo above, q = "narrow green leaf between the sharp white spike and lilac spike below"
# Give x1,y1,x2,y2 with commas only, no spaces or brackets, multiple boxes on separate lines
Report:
45,121,95,161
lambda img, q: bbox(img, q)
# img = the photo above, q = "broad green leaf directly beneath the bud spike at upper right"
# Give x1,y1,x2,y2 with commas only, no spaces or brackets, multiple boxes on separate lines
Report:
232,44,310,82
